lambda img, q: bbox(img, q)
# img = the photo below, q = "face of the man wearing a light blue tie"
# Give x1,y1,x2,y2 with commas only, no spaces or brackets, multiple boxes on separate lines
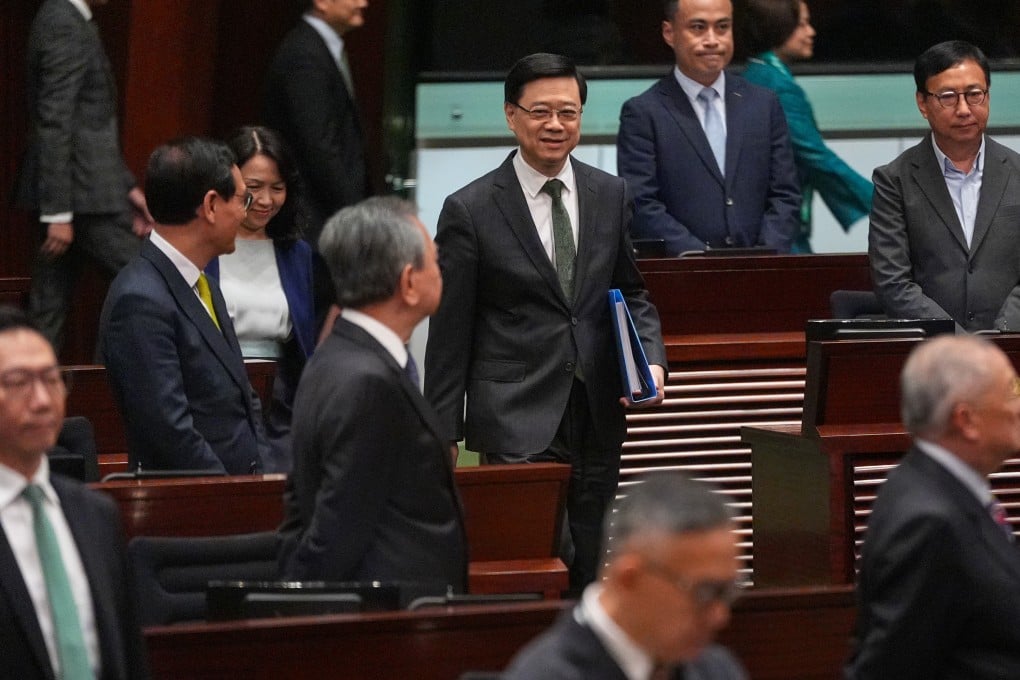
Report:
662,0,733,86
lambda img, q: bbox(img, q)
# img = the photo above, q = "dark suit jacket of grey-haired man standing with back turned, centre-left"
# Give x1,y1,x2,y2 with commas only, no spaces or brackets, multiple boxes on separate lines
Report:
279,318,467,590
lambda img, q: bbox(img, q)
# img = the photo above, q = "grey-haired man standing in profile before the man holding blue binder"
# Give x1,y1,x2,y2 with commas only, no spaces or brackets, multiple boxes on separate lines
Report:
279,198,467,592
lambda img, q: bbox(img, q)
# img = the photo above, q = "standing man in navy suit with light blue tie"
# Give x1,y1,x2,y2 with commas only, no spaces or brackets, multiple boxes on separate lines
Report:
616,0,801,255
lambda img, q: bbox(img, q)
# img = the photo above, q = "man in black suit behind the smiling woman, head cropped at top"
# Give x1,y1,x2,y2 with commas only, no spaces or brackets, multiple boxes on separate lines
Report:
262,0,370,246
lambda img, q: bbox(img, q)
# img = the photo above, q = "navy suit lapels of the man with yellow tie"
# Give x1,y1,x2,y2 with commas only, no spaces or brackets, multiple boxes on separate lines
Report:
141,241,251,401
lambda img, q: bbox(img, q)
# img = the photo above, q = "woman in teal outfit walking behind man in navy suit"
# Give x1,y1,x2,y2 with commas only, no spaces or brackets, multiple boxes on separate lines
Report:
737,0,873,253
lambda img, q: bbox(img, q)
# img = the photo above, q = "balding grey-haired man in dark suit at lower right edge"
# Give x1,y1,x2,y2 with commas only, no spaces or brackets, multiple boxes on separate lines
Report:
846,335,1020,680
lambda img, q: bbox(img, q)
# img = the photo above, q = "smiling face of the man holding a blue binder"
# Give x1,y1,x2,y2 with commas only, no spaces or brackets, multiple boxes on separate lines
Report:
503,77,581,177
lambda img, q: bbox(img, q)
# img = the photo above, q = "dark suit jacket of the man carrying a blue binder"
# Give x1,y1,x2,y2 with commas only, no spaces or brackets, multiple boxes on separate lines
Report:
425,152,666,455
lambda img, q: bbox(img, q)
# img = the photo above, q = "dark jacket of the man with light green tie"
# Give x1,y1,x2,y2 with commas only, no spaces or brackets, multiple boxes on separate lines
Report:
0,475,149,680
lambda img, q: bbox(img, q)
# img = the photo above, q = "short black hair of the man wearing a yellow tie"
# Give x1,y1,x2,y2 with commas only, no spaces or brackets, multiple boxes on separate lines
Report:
145,137,237,224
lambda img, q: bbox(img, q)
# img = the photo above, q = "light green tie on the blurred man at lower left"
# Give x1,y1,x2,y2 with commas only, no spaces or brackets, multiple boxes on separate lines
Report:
21,484,95,680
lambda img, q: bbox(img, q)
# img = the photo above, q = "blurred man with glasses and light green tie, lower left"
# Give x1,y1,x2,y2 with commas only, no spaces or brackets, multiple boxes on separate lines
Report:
0,307,149,680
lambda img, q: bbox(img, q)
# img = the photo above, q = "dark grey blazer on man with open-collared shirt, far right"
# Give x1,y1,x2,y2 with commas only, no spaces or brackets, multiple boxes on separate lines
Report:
868,134,1020,331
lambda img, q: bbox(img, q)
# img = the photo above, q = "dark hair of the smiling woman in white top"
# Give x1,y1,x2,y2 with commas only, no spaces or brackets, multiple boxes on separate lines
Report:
226,125,308,247
